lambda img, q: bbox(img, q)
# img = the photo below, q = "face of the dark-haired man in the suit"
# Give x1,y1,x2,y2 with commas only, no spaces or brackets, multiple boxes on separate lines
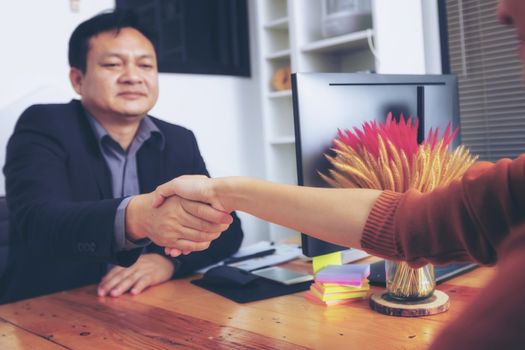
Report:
70,28,158,122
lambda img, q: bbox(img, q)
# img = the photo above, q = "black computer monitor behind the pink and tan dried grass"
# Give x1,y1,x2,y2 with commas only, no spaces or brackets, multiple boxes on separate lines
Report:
292,73,459,256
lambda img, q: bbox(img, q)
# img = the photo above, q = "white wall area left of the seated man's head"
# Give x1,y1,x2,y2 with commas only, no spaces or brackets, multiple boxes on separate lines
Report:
0,0,114,195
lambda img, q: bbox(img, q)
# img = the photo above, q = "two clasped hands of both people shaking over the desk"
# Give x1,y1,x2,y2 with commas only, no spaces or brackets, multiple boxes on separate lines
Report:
126,175,229,257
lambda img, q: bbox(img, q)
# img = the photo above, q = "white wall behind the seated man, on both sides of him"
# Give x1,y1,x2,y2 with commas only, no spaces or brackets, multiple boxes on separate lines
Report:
0,0,267,243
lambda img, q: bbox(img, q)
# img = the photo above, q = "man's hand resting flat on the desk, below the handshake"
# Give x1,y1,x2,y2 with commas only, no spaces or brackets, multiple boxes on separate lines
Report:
98,253,174,297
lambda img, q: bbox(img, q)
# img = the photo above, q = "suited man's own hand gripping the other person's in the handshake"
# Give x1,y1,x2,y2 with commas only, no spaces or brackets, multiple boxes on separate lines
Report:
126,192,233,252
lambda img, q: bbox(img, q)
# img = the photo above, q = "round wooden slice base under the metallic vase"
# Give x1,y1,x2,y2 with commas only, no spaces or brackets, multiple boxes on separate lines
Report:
370,290,450,317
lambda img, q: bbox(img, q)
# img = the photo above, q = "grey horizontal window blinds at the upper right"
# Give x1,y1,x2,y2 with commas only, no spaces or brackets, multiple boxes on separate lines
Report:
446,0,525,161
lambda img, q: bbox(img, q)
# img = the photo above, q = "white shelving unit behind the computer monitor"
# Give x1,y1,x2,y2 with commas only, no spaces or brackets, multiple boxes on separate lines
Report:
252,0,376,241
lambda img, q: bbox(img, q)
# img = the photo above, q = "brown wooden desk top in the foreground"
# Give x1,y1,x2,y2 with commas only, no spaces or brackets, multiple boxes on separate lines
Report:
0,262,493,350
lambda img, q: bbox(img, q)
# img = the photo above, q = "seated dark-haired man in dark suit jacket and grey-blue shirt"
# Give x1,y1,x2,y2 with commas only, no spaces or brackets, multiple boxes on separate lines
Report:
0,12,243,303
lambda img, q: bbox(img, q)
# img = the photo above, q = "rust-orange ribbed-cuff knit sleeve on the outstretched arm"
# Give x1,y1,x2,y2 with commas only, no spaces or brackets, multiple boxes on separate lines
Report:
361,155,525,266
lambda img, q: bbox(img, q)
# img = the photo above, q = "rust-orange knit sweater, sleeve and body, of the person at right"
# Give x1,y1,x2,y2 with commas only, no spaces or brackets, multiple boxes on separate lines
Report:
361,156,525,350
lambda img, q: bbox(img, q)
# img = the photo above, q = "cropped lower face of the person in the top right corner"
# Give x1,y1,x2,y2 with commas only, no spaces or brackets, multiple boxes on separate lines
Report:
498,0,525,74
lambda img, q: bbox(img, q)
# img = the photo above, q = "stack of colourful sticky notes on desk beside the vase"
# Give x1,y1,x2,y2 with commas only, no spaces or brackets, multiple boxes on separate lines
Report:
305,264,370,305
